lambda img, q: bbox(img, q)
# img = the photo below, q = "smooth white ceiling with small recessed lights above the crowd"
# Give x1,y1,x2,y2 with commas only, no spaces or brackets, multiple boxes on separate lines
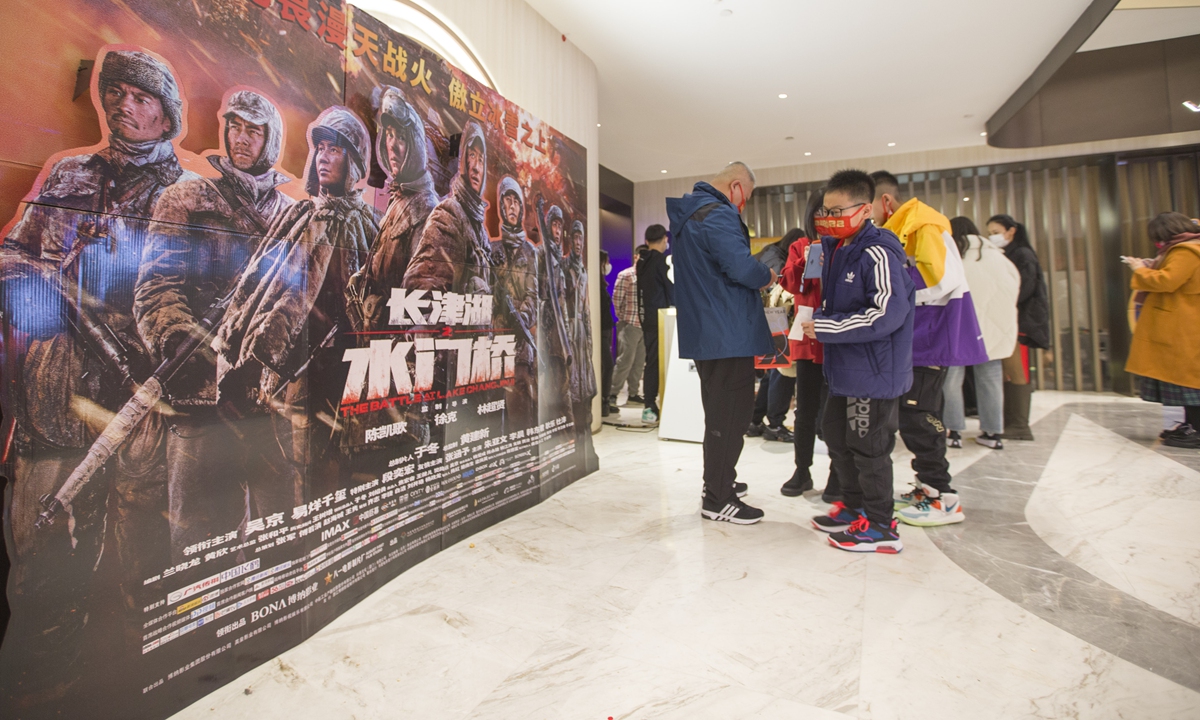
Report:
527,0,1090,182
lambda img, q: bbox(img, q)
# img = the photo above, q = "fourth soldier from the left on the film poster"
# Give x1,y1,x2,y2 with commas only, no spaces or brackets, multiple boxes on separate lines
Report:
355,86,438,330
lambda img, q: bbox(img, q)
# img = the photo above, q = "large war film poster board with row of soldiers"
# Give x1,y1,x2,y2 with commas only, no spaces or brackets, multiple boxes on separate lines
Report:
0,0,596,719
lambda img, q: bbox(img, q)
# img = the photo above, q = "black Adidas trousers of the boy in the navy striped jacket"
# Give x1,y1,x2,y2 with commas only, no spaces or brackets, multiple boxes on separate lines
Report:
822,397,900,524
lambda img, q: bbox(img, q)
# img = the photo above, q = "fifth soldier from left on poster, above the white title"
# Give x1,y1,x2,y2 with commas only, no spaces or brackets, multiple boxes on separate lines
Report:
403,122,492,295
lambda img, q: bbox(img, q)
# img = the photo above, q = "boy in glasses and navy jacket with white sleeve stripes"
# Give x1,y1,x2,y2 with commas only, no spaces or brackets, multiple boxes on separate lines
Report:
804,170,916,553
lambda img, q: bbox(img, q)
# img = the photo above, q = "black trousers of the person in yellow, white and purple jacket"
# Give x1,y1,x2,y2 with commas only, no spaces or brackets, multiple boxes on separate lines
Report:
900,367,954,493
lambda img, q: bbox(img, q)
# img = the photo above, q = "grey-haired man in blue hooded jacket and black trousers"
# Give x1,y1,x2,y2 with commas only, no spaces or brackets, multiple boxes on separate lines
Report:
672,162,772,524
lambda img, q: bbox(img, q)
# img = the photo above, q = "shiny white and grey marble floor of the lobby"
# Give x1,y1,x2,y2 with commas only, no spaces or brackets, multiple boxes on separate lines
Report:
175,392,1200,720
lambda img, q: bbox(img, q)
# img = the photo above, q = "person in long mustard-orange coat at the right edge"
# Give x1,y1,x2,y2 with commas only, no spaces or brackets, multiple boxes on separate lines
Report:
1123,212,1200,448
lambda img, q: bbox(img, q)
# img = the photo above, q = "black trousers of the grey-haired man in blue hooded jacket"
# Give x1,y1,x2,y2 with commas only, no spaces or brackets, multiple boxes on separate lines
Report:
696,355,754,505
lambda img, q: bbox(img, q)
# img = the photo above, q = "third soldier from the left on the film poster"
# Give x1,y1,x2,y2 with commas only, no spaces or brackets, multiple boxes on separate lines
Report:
212,106,379,494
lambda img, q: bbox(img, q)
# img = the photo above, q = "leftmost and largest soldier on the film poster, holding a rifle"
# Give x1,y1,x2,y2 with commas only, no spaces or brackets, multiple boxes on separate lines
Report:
0,50,196,698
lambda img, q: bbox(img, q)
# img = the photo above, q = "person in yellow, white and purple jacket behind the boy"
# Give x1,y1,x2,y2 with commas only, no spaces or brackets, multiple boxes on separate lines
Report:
871,170,988,526
